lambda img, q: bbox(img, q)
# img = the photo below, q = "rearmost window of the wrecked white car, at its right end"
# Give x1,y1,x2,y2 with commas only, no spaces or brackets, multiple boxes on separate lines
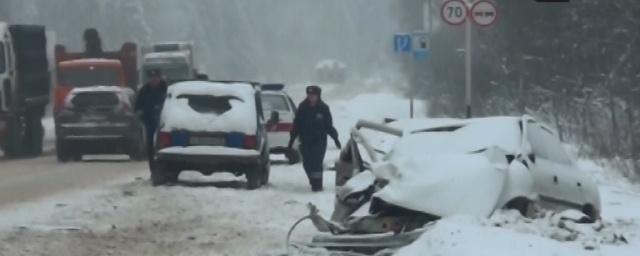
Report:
527,123,571,164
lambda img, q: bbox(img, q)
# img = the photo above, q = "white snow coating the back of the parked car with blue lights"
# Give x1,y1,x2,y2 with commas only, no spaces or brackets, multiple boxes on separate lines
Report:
160,81,257,135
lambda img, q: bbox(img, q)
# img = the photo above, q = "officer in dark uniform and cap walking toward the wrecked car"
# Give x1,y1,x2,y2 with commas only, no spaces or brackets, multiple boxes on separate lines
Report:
289,85,342,192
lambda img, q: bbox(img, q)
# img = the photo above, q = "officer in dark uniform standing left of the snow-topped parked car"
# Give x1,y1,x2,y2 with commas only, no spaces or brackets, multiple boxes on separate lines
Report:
136,70,167,162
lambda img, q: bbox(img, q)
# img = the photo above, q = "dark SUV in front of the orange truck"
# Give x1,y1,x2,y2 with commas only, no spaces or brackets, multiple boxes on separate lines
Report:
56,86,146,162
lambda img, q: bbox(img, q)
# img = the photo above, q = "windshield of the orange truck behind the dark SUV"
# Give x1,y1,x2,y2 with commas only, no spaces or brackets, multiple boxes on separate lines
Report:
58,68,120,87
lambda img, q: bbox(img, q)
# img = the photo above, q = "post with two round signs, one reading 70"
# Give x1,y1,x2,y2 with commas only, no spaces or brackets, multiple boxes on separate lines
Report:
440,0,498,118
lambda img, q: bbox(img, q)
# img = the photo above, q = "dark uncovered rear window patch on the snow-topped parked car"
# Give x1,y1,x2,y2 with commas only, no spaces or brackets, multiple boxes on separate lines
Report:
177,94,244,115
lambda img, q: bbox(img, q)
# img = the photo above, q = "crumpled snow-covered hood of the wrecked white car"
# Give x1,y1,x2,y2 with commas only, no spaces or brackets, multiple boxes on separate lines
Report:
372,148,507,217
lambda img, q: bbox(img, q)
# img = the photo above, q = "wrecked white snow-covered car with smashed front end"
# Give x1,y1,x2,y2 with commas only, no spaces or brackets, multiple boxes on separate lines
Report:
304,116,601,252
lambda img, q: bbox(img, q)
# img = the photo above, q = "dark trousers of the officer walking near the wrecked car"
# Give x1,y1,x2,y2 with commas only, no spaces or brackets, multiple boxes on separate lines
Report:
300,139,327,191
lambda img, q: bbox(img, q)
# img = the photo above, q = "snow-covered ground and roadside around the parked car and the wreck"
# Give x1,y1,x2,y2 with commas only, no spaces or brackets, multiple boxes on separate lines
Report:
0,87,640,256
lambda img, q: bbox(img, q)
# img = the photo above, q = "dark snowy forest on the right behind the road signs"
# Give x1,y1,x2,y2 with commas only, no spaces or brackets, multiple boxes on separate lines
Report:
405,0,640,177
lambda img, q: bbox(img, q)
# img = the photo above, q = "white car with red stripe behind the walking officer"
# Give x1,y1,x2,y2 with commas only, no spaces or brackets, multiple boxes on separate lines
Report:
261,84,301,164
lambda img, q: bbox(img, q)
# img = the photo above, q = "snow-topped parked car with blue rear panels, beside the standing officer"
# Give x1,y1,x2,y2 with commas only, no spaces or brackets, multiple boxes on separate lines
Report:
151,81,270,189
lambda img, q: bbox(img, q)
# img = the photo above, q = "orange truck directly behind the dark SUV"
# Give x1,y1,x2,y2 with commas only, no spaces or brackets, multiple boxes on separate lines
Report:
54,42,138,114
